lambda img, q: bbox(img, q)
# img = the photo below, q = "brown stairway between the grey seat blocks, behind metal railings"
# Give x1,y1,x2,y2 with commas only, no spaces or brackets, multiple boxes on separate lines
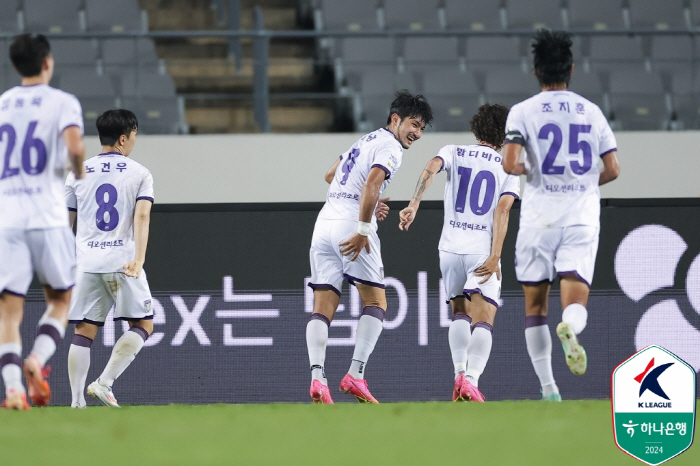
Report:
139,0,348,134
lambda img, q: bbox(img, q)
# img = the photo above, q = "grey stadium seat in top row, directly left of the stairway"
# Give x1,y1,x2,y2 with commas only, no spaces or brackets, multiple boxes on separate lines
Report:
85,0,142,32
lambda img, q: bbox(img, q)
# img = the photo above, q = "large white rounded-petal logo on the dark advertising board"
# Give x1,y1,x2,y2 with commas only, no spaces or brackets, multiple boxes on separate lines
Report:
615,225,700,372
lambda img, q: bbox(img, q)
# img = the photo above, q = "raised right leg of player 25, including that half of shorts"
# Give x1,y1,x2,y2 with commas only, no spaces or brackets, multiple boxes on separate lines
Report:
554,226,599,375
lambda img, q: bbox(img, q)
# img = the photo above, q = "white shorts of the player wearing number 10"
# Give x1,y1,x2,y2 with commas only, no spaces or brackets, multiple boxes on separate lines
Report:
440,251,501,307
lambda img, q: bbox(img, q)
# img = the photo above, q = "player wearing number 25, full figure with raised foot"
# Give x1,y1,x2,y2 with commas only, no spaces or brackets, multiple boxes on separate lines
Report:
503,30,620,401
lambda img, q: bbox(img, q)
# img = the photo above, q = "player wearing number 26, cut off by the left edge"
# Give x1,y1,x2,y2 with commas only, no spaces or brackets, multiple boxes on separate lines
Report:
0,34,85,409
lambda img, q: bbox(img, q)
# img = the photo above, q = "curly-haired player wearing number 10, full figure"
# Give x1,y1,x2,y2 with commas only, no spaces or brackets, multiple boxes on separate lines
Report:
399,104,520,402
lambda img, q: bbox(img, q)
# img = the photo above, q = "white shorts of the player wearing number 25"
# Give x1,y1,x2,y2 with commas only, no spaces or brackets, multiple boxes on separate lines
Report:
515,225,600,287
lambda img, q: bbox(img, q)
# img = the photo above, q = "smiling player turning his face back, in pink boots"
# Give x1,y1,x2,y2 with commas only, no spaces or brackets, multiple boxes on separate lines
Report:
306,90,433,403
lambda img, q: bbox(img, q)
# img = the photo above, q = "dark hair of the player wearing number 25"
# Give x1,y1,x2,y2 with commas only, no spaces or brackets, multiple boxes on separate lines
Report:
532,29,574,86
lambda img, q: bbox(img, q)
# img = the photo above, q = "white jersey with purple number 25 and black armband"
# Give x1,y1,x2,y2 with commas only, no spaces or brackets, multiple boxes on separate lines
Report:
506,91,617,228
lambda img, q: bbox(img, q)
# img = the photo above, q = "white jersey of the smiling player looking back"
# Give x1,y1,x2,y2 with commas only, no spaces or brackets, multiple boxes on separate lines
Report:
318,128,403,228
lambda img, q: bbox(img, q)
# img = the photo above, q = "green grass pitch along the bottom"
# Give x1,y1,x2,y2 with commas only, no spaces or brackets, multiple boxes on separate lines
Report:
0,401,700,466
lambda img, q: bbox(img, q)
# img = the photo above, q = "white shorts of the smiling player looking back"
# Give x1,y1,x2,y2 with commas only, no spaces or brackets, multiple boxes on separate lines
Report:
309,219,384,296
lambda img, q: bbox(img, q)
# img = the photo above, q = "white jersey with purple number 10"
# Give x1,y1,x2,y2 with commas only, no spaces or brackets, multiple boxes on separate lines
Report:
437,144,520,255
